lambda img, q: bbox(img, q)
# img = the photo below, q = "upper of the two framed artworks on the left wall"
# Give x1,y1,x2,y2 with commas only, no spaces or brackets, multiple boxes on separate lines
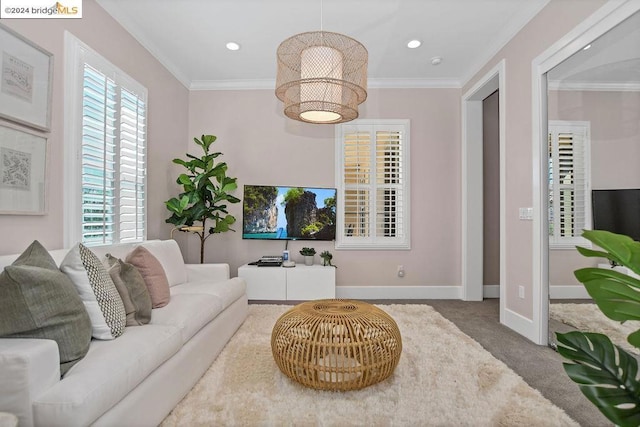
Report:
0,24,53,131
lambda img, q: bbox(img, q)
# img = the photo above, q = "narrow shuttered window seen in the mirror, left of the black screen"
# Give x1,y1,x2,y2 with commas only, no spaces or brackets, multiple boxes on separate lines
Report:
549,121,591,248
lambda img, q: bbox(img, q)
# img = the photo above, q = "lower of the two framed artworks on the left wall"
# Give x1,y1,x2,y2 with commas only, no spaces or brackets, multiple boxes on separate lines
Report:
0,123,47,215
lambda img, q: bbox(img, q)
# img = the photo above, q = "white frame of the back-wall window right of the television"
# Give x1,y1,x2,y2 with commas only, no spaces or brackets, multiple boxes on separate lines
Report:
335,119,411,250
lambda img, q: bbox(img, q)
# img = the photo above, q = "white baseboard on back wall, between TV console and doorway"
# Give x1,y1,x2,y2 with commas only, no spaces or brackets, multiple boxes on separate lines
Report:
336,286,462,299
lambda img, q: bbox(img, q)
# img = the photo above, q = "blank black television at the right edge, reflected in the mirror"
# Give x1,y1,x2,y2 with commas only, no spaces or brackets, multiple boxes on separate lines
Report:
591,189,640,241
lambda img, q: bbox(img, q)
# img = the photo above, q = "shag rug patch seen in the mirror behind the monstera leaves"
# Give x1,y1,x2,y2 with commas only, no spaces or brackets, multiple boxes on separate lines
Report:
549,303,640,354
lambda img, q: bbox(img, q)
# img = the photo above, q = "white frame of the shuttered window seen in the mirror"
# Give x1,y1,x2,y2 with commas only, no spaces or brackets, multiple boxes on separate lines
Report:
547,120,592,250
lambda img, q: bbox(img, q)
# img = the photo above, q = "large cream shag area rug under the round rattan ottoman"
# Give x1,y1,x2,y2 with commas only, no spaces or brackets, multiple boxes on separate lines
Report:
162,304,578,427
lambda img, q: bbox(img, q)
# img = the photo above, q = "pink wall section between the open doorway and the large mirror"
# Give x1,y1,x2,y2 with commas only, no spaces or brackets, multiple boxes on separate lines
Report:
462,0,605,319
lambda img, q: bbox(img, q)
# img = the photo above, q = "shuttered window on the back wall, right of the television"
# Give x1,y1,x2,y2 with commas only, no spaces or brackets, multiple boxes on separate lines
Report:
336,120,410,249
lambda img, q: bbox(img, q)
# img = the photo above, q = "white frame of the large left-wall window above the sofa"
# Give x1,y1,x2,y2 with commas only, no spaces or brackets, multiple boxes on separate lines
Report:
63,31,148,247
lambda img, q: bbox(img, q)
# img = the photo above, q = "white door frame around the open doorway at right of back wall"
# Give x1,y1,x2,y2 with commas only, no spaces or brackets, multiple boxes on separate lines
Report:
461,59,506,322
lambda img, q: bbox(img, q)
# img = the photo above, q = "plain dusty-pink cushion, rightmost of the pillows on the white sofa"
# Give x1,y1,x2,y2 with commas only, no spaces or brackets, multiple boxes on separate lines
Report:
125,246,171,308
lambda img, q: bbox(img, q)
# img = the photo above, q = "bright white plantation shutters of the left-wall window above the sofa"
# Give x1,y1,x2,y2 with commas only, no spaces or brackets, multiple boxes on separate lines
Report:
81,63,146,245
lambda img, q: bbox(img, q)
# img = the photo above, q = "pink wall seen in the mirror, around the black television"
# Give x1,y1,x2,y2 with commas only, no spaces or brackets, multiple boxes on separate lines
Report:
548,90,640,286
